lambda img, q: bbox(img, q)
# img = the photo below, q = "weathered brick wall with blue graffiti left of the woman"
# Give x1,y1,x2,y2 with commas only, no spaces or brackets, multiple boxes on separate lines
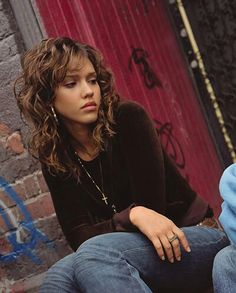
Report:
0,0,70,292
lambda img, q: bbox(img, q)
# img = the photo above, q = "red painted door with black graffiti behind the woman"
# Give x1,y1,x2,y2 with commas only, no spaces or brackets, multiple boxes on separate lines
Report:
36,0,222,212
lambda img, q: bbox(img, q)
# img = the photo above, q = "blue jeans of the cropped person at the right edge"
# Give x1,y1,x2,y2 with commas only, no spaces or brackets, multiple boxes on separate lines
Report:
213,245,236,293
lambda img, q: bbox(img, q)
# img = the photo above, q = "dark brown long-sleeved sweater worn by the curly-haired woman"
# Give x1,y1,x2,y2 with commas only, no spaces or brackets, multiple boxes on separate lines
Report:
43,101,210,250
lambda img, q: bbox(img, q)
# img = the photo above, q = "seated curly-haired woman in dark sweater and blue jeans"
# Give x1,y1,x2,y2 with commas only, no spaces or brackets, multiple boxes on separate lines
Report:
17,38,228,292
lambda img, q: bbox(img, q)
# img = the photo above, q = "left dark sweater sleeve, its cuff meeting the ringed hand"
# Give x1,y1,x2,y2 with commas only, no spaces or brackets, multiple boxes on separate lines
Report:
42,167,134,251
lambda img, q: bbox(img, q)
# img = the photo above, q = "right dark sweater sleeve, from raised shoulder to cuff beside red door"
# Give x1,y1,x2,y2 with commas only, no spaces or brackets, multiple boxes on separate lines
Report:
117,102,208,226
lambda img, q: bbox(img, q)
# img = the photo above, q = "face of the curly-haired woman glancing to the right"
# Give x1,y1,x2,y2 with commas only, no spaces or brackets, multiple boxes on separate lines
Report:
54,57,101,129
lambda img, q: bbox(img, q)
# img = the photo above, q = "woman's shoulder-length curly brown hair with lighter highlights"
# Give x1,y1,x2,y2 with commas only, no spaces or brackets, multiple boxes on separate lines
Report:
14,38,119,175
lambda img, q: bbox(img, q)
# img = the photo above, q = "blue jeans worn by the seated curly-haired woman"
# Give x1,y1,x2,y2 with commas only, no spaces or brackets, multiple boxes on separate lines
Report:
40,226,229,293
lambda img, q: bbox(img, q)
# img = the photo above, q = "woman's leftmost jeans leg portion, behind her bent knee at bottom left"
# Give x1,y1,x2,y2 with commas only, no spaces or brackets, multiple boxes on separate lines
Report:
40,253,80,293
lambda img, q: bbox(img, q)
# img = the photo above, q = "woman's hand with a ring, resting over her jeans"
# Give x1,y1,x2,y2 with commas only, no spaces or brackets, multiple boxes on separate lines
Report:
130,206,191,263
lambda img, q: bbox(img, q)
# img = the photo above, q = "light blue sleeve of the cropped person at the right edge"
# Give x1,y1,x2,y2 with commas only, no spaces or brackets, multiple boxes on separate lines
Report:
219,164,236,244
